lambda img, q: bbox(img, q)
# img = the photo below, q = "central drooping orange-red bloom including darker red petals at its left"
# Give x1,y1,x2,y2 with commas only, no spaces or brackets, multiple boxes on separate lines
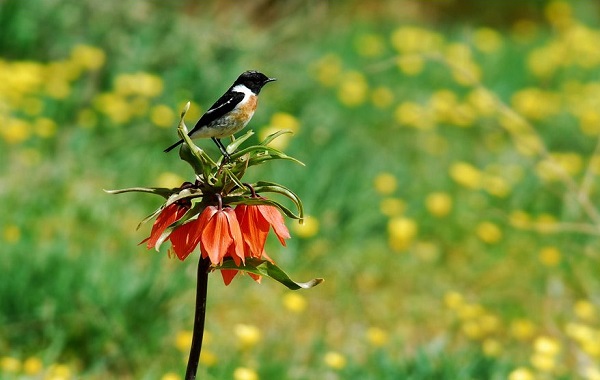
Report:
170,206,244,265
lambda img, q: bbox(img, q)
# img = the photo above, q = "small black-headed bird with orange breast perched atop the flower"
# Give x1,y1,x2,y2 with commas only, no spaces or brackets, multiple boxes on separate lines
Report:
164,70,277,159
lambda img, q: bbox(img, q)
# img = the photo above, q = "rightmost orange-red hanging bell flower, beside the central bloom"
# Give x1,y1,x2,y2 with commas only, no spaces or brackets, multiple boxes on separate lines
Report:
235,204,290,259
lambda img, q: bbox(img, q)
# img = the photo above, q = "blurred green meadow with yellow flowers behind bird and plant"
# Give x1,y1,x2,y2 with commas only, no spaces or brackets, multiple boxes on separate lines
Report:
0,0,600,380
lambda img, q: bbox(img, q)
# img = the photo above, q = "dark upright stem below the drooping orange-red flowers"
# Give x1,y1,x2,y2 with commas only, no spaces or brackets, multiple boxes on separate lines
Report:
185,257,210,380
